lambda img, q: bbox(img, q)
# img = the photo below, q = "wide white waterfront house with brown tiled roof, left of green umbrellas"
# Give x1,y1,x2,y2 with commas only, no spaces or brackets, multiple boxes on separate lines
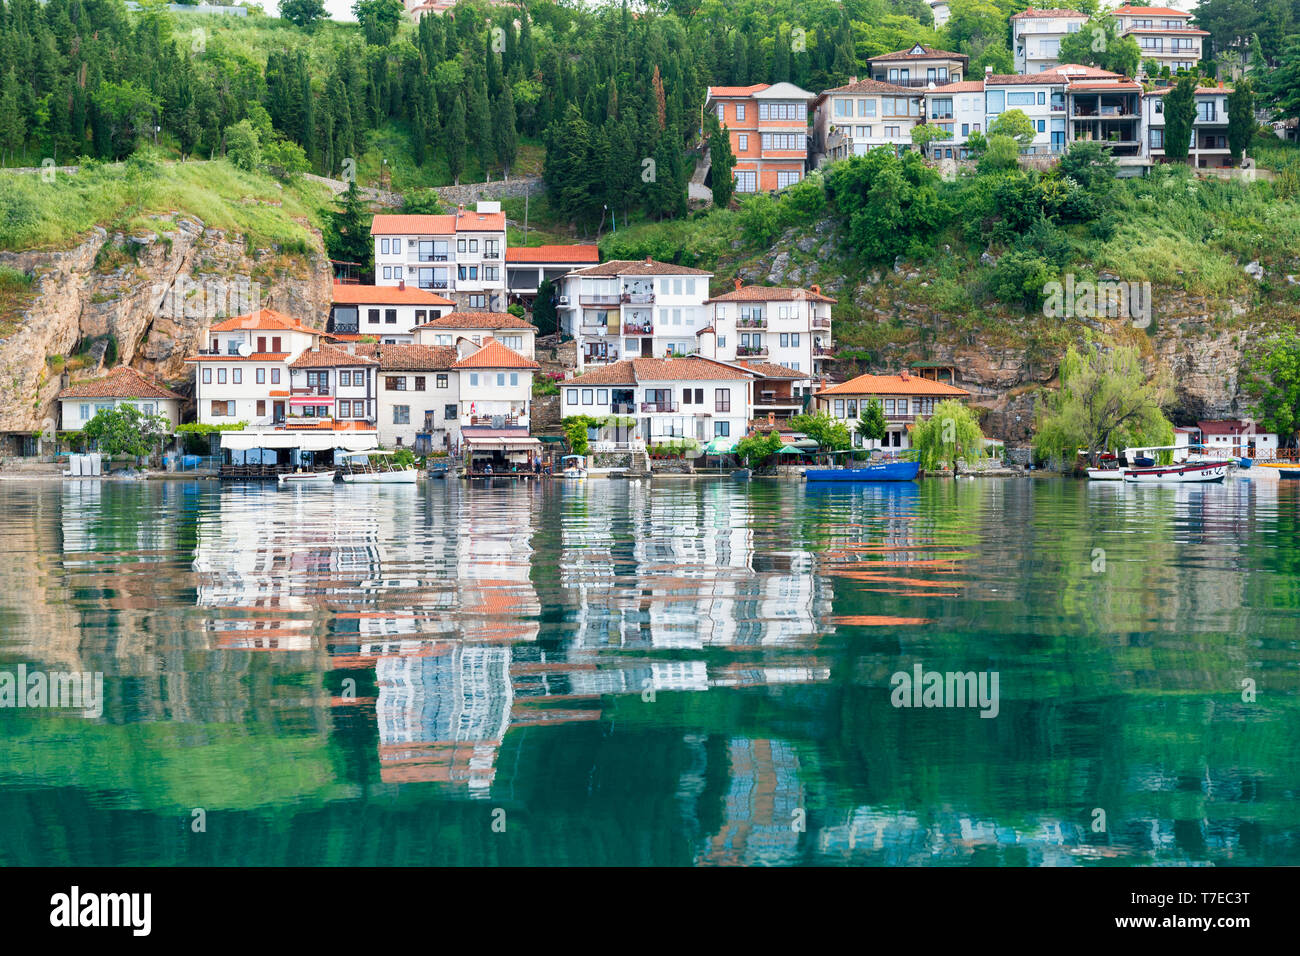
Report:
560,358,755,453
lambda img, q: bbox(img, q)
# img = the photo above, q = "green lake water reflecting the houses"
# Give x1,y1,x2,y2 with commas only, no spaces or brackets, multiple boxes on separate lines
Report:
0,479,1300,866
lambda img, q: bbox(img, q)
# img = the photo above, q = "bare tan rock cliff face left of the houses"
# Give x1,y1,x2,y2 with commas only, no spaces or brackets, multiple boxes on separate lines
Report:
0,215,332,432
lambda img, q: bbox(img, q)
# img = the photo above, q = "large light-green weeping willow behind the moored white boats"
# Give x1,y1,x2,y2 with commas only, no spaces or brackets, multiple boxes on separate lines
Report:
1034,346,1174,464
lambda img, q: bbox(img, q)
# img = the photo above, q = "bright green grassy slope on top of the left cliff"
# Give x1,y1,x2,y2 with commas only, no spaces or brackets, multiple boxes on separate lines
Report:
0,153,329,252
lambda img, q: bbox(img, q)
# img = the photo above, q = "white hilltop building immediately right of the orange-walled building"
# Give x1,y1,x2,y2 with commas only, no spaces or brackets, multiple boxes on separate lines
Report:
813,77,925,166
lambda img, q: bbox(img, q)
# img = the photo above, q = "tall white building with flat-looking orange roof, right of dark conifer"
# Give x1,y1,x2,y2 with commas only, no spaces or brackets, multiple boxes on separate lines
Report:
371,202,507,312
